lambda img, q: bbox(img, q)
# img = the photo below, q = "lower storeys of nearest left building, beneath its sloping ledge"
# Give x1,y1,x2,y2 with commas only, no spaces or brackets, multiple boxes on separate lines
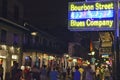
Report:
0,18,28,79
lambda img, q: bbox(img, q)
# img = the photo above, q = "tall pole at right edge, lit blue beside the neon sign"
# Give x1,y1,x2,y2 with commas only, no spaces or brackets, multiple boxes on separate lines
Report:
114,0,120,80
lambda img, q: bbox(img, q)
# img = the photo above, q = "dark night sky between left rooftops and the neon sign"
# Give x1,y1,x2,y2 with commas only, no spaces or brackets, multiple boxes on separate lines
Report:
24,0,84,41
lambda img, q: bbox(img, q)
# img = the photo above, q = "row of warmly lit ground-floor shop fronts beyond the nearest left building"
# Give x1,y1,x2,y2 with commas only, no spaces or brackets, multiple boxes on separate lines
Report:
22,52,57,68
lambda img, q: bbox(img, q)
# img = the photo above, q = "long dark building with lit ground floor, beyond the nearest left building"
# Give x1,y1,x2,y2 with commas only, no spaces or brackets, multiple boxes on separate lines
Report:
22,25,67,67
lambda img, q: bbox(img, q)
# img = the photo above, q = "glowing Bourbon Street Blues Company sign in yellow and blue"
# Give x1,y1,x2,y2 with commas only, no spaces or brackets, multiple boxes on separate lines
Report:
68,1,115,31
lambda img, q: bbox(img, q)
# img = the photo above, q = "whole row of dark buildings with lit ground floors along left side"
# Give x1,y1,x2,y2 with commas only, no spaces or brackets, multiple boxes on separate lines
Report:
0,0,67,80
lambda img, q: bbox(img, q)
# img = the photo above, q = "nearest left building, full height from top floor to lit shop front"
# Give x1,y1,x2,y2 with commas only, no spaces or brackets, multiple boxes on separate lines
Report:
0,0,25,80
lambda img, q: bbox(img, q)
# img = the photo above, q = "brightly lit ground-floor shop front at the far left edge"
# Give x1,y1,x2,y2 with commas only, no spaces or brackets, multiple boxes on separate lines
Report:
0,45,21,79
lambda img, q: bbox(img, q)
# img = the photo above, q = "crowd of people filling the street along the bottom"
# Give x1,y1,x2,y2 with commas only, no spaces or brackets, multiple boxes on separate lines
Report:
0,62,112,80
